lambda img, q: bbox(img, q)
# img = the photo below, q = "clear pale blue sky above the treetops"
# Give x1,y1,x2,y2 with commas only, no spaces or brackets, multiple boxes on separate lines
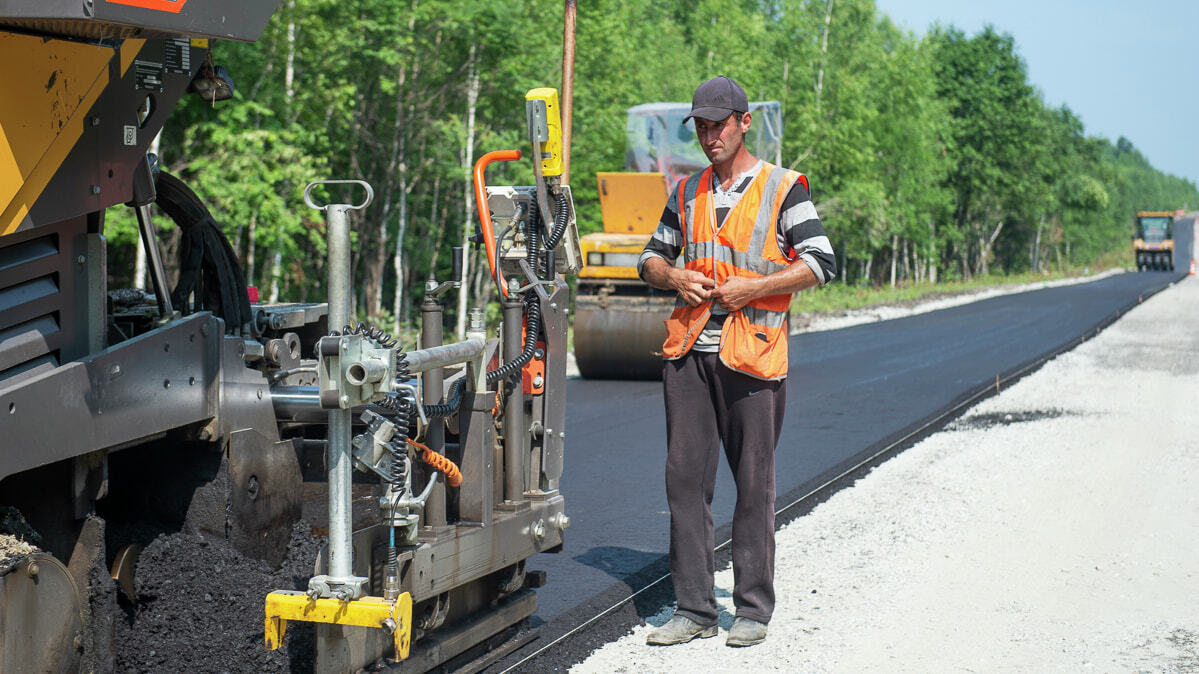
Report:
872,0,1199,183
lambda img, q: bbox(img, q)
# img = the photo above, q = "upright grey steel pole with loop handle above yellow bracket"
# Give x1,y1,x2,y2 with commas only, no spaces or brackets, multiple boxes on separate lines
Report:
325,204,354,578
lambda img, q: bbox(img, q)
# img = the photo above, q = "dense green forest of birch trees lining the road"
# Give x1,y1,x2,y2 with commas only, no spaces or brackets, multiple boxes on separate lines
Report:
106,0,1199,332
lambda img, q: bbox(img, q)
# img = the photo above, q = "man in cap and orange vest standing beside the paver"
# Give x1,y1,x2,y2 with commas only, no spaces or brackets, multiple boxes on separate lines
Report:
638,77,836,646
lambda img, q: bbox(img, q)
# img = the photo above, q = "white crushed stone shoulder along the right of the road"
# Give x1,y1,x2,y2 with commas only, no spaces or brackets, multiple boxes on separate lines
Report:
572,278,1199,673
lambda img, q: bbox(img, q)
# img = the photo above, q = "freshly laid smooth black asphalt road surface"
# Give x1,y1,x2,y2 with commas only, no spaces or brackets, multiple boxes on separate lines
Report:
529,272,1181,626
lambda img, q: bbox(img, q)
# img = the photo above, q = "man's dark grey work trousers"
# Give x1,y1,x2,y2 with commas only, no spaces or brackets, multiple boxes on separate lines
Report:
662,351,787,626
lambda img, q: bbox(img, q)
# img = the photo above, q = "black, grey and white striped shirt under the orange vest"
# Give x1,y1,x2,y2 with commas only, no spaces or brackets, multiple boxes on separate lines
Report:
637,161,837,351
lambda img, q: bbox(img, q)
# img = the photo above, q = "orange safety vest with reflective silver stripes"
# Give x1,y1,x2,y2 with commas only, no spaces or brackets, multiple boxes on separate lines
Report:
662,163,808,380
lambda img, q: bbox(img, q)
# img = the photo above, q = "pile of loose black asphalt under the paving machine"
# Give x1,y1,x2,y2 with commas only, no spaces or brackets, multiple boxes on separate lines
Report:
116,520,323,673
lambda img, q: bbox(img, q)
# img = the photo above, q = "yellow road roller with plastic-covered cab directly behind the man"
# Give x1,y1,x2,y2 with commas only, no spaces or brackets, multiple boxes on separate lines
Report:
574,101,783,379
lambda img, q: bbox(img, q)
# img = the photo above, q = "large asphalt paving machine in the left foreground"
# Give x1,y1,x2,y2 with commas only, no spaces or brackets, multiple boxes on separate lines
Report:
0,0,582,673
